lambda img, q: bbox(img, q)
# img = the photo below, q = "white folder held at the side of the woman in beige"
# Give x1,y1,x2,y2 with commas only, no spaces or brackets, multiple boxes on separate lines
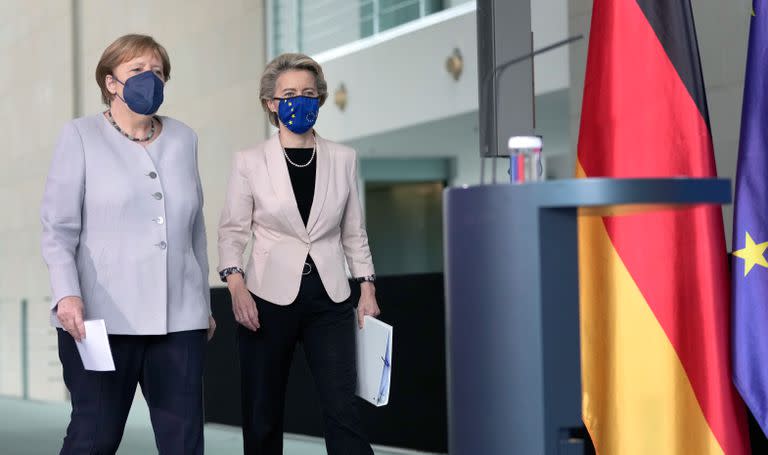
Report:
356,316,392,406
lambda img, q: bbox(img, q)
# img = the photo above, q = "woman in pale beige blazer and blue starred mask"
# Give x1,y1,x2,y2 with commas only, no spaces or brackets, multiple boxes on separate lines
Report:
219,54,379,455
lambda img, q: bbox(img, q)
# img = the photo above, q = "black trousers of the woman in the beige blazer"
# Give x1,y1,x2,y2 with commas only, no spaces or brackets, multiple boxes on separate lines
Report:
238,271,373,455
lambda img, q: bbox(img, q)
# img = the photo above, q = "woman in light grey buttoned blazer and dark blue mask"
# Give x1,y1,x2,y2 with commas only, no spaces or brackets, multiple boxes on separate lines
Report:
41,35,215,455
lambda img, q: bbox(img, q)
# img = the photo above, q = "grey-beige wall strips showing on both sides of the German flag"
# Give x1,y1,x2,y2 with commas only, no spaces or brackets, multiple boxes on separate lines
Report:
569,0,751,247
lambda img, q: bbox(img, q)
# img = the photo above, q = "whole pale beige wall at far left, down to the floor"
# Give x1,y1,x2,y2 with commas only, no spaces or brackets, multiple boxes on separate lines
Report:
0,0,74,399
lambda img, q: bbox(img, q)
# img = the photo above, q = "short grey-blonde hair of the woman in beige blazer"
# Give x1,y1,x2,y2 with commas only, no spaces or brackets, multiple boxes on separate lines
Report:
259,54,328,126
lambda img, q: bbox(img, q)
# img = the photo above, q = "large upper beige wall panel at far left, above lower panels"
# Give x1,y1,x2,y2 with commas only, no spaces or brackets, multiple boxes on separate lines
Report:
0,0,73,324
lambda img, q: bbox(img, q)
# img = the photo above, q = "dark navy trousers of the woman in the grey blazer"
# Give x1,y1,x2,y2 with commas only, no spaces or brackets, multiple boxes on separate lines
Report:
58,329,206,455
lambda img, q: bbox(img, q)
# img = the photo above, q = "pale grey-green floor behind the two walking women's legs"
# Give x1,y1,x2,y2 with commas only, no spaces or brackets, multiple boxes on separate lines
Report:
0,397,426,455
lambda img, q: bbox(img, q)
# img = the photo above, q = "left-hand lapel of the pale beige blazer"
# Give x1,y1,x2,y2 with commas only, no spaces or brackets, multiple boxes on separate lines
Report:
264,134,309,241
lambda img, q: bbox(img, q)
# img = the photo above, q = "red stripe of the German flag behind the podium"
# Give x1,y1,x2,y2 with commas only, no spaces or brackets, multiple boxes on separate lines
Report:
579,0,748,454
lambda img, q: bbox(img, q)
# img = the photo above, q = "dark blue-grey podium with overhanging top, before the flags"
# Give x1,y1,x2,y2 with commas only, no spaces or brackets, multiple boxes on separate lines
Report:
443,178,730,455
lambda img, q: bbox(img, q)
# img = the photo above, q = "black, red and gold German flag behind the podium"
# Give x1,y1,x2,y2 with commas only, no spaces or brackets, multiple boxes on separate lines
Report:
577,0,749,455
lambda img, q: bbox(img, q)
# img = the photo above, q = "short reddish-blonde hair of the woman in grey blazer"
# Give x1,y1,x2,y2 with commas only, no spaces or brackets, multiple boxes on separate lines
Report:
96,34,171,106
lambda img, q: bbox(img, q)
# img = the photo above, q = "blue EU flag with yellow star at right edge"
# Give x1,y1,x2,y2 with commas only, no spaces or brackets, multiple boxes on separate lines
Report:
731,0,768,434
